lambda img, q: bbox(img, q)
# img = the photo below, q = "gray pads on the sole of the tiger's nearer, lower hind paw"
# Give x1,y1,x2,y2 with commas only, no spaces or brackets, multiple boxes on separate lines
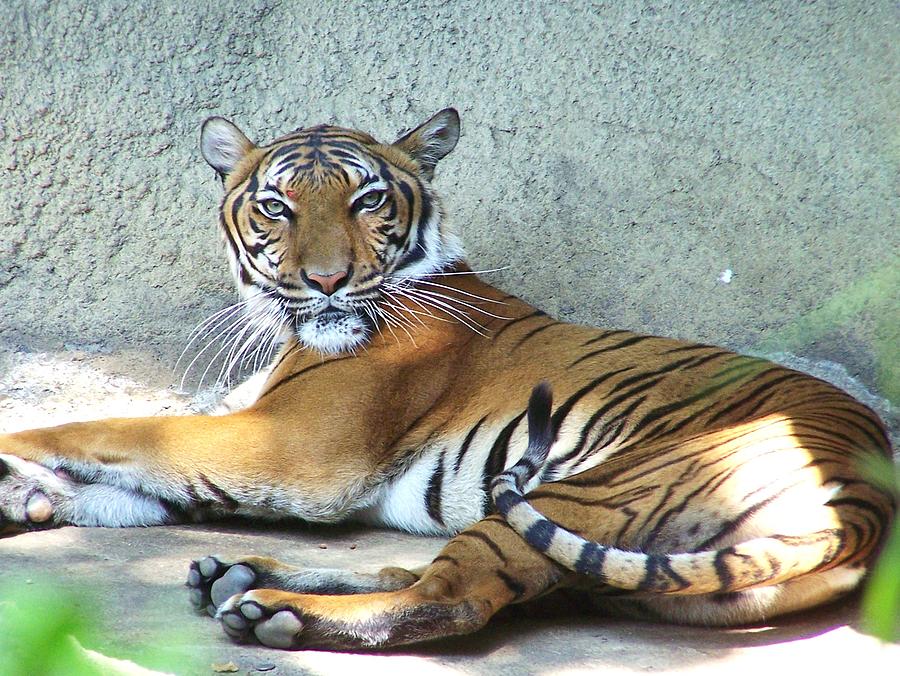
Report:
216,591,303,650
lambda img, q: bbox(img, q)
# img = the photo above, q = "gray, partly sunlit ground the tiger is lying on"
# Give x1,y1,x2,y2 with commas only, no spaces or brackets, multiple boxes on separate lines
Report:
0,352,900,676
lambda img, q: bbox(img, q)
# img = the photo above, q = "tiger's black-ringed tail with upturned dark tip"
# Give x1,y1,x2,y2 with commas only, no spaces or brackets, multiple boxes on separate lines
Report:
491,382,856,594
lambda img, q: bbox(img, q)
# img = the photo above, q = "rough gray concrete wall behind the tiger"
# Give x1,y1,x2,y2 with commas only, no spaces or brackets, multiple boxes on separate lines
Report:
0,0,900,400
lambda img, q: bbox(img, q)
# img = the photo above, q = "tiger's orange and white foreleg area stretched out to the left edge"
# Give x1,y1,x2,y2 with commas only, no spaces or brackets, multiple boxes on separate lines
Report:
0,411,357,533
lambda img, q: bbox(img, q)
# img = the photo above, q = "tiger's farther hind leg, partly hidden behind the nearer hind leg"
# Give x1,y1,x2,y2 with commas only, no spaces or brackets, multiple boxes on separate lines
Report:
186,556,419,616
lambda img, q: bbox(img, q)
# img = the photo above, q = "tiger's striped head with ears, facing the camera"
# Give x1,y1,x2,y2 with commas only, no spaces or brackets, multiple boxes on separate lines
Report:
200,108,462,353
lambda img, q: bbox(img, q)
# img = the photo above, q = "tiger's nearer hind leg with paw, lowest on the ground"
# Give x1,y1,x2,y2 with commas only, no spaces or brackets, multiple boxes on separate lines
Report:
205,516,569,649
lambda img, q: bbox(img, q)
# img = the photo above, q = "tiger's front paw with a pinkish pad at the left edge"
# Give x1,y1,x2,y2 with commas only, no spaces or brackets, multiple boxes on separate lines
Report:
0,454,75,535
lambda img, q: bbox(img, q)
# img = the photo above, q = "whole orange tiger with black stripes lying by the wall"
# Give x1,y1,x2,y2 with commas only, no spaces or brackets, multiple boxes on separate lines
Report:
0,108,895,650
